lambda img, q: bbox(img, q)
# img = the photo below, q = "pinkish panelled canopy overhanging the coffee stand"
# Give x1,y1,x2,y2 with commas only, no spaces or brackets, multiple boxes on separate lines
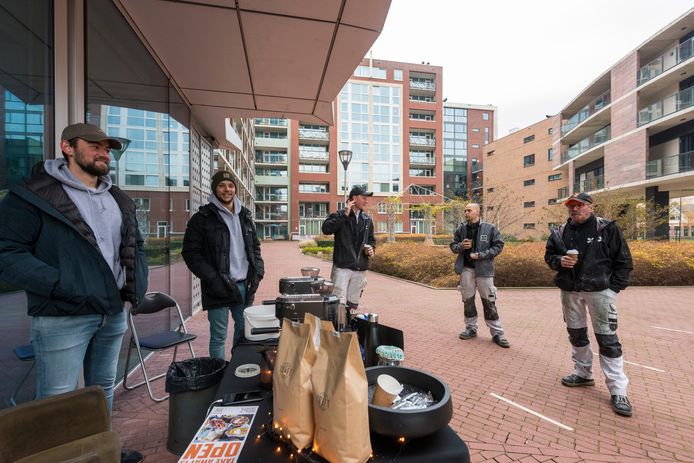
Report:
116,0,390,147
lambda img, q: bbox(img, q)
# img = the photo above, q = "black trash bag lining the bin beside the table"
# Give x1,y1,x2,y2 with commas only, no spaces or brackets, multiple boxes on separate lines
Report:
166,357,227,394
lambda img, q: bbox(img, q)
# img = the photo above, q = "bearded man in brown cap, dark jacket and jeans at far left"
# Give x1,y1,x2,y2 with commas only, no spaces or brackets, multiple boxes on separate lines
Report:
0,123,147,462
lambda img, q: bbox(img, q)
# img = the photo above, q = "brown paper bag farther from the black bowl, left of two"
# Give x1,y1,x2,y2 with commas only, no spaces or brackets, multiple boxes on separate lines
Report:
272,318,316,449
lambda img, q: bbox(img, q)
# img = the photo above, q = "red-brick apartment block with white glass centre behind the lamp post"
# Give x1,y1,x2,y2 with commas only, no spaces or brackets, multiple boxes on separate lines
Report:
289,59,443,236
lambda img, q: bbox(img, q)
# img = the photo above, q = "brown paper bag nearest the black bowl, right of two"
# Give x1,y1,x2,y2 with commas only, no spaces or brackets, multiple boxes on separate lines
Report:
311,330,371,463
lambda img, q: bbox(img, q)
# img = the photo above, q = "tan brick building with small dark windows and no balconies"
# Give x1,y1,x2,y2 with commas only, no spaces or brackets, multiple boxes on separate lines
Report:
483,116,568,239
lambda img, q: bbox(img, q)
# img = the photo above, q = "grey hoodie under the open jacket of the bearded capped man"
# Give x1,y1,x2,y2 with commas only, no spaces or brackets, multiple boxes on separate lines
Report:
43,159,125,289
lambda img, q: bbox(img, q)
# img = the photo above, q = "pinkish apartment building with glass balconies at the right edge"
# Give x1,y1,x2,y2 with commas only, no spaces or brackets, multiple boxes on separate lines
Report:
554,9,694,237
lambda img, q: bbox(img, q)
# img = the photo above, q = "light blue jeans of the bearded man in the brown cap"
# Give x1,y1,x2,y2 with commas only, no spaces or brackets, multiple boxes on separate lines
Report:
31,311,128,414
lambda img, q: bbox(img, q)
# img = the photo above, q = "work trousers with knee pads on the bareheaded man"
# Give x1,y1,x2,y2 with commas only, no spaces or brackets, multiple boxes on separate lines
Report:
459,267,504,336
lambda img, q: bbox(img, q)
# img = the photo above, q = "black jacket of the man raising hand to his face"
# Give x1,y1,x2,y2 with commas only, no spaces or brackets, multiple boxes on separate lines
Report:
322,211,376,271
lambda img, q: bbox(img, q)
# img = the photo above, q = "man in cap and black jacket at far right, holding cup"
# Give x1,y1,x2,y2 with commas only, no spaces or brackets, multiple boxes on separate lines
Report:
545,193,633,416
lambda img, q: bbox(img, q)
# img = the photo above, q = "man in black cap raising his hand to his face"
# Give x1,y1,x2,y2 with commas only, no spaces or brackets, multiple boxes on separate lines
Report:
322,186,376,313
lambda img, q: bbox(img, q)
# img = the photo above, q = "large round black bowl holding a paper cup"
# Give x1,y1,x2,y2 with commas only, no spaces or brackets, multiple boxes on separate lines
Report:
366,366,453,439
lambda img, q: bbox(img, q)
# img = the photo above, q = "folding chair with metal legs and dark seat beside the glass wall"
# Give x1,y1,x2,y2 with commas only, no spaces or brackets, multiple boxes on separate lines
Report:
123,293,197,402
